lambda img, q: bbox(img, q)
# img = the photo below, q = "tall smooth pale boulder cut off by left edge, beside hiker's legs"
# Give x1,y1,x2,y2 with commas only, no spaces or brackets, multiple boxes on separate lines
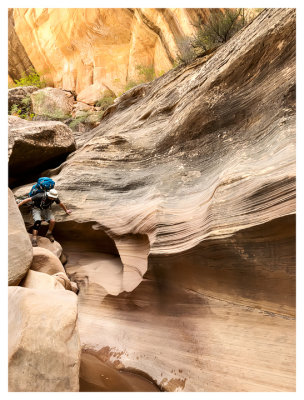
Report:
8,189,33,285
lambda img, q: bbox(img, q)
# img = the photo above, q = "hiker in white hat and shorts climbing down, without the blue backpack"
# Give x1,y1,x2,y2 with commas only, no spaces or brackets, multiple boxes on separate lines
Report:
18,189,72,247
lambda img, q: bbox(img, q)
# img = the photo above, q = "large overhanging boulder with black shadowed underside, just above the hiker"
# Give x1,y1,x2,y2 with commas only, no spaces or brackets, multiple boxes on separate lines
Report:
8,116,76,184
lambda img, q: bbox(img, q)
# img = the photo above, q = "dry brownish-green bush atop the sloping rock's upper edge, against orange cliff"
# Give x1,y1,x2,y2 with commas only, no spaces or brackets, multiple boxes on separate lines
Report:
177,8,254,65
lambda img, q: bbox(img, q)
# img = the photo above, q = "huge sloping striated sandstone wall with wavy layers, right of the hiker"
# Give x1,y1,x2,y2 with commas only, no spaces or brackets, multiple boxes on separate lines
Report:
15,9,295,391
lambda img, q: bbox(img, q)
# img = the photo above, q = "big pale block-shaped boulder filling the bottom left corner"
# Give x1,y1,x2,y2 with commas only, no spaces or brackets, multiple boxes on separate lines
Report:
8,286,80,392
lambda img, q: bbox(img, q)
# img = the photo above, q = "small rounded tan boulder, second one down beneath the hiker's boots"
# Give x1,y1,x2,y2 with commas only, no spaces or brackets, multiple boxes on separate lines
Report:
31,247,65,275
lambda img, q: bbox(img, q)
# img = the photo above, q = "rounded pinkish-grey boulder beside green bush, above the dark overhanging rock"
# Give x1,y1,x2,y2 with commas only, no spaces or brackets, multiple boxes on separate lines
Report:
31,87,74,121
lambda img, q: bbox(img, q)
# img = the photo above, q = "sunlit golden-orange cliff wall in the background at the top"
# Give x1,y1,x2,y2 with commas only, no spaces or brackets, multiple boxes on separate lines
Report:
13,8,206,99
